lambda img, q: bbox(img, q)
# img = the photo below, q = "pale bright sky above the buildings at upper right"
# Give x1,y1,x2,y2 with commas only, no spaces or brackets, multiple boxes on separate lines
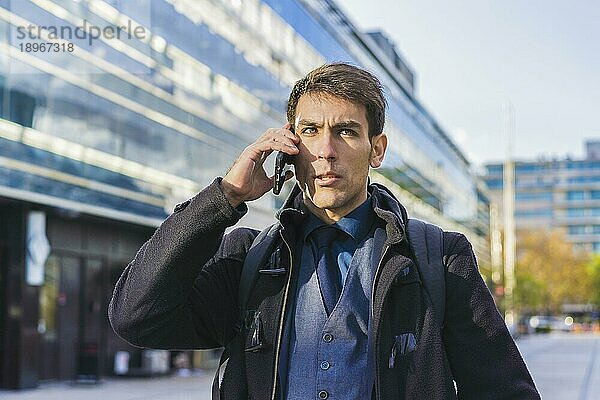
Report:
336,0,600,167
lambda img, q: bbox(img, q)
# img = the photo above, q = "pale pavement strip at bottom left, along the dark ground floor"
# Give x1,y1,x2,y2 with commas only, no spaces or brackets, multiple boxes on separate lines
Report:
0,370,213,400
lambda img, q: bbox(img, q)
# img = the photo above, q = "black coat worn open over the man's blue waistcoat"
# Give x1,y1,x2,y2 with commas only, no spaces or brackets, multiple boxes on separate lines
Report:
109,179,539,400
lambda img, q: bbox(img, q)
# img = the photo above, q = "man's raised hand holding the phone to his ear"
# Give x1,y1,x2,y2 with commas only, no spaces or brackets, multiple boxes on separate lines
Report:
221,123,300,207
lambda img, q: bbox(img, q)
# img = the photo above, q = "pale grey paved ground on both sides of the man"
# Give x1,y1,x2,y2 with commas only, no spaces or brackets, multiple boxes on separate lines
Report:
0,333,600,400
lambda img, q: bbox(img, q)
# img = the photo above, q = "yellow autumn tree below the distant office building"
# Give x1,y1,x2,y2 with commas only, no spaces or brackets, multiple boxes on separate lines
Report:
515,230,598,313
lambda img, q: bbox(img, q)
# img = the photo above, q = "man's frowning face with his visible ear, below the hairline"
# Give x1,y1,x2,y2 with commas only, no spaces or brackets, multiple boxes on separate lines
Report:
294,93,387,221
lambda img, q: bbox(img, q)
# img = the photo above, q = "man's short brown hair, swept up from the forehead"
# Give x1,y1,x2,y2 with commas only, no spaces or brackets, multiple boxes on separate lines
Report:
287,63,386,139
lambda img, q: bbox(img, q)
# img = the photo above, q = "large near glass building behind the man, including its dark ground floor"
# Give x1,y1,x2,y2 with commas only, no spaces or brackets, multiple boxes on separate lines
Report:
0,0,489,388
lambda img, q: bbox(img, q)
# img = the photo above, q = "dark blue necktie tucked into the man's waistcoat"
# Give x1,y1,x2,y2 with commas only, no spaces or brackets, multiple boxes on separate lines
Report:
312,226,342,316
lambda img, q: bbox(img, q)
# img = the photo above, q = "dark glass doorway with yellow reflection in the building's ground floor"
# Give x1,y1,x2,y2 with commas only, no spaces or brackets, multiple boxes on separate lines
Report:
38,252,107,380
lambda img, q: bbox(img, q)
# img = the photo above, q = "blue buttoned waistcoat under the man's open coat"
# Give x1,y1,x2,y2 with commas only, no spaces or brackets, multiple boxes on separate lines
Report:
282,198,385,400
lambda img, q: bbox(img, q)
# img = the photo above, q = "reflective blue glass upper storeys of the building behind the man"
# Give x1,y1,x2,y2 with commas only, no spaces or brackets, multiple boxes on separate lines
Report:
0,0,478,234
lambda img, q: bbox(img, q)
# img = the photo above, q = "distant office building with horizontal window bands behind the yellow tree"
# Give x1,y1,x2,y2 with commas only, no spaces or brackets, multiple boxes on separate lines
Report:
483,141,600,253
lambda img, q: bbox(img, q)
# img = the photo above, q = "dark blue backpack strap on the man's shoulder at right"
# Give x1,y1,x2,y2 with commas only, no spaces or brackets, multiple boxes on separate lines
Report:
406,218,446,328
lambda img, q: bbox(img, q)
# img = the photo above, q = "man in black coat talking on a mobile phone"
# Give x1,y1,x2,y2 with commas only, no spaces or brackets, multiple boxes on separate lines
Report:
109,63,539,399
